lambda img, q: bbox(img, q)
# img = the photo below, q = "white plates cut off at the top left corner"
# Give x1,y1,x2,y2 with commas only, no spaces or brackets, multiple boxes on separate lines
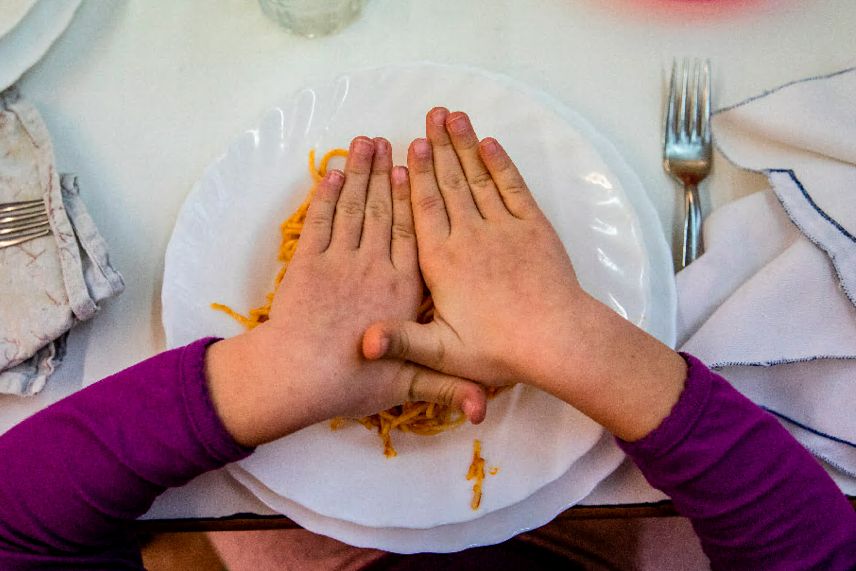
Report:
0,0,80,91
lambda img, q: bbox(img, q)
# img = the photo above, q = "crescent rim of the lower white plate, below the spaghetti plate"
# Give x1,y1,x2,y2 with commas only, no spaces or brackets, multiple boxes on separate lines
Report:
229,432,624,553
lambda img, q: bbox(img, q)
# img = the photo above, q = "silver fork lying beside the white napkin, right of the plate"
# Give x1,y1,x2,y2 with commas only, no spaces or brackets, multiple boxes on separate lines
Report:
663,59,712,268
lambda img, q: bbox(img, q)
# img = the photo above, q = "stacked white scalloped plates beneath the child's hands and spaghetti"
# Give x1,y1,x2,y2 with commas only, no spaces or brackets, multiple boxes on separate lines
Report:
163,64,675,553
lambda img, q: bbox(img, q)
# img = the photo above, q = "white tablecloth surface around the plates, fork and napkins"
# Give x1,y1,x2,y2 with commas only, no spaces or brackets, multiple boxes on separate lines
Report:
0,0,856,519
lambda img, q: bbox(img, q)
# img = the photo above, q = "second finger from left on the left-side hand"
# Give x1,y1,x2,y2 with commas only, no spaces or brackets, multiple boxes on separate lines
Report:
330,137,374,250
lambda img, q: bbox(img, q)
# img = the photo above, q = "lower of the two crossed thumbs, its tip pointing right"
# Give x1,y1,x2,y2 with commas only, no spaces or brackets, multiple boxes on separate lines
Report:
402,363,487,424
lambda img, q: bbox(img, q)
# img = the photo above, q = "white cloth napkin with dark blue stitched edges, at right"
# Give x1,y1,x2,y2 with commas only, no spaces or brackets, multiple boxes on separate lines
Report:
677,69,856,477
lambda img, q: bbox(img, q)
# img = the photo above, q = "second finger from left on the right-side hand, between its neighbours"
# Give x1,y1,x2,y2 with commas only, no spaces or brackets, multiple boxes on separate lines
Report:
425,107,481,227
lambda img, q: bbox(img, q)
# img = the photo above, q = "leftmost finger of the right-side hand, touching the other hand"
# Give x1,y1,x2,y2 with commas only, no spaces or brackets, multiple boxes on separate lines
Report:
407,139,450,246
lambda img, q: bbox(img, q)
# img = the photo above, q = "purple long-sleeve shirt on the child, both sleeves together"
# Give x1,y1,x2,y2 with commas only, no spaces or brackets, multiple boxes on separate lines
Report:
0,339,856,570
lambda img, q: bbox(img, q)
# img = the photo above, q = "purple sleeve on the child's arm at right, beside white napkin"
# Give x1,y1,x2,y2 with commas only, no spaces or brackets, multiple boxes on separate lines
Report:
619,355,856,570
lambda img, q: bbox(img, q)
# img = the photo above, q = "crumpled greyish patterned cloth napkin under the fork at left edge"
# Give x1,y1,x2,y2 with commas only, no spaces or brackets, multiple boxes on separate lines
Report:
0,88,125,395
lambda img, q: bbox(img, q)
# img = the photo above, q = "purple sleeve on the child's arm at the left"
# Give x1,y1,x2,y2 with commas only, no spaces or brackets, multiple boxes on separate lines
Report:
0,339,251,570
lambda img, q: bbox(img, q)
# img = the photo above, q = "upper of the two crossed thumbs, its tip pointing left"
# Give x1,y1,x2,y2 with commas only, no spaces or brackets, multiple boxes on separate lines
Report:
363,321,446,371
